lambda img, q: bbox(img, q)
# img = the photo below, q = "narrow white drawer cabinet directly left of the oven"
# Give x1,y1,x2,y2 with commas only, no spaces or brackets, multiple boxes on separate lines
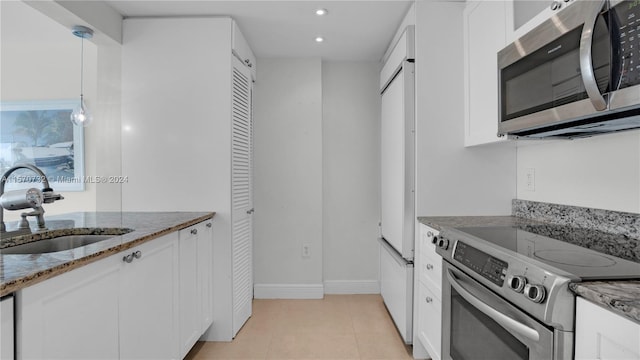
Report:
414,224,442,360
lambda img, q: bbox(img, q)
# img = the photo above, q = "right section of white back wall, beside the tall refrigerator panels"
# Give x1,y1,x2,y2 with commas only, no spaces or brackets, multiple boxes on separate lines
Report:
322,62,380,293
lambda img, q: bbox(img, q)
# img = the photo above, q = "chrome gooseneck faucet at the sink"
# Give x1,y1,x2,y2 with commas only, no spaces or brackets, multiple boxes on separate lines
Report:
0,164,64,233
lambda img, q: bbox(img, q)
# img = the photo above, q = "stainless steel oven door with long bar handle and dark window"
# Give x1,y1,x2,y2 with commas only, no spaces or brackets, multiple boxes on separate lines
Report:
442,261,555,360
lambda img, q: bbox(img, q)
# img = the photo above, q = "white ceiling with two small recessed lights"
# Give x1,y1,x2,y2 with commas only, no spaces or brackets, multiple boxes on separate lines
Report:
105,0,413,61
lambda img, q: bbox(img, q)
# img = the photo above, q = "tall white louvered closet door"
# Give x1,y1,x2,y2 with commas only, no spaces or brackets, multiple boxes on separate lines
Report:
231,57,253,337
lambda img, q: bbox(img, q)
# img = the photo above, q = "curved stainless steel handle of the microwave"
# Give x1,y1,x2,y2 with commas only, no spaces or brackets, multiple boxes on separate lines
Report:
580,0,607,111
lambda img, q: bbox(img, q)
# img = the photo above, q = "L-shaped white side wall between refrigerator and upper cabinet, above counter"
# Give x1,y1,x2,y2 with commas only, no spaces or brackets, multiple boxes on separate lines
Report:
415,1,516,216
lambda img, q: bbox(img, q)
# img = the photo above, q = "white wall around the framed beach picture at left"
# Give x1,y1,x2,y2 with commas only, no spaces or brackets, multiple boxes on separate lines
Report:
0,1,120,220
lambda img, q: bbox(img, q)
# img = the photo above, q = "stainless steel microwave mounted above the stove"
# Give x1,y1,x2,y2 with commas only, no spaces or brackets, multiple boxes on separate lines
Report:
498,0,640,138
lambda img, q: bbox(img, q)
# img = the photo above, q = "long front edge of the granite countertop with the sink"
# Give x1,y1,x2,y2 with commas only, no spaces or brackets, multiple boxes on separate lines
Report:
0,212,216,297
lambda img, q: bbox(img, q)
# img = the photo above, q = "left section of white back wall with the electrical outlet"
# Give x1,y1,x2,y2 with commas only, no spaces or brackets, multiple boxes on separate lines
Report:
254,59,323,297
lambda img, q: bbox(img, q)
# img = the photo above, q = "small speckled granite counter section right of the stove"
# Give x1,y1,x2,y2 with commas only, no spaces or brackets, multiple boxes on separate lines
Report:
569,281,640,324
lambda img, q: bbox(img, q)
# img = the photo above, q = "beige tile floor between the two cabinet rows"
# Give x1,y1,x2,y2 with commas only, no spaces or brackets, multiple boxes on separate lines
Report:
185,295,412,360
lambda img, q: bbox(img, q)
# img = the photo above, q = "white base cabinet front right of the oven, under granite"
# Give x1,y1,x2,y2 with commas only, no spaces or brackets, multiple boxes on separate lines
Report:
575,297,640,360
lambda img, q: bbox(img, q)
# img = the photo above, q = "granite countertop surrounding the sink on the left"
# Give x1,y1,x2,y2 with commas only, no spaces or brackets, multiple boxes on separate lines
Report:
0,212,215,297
